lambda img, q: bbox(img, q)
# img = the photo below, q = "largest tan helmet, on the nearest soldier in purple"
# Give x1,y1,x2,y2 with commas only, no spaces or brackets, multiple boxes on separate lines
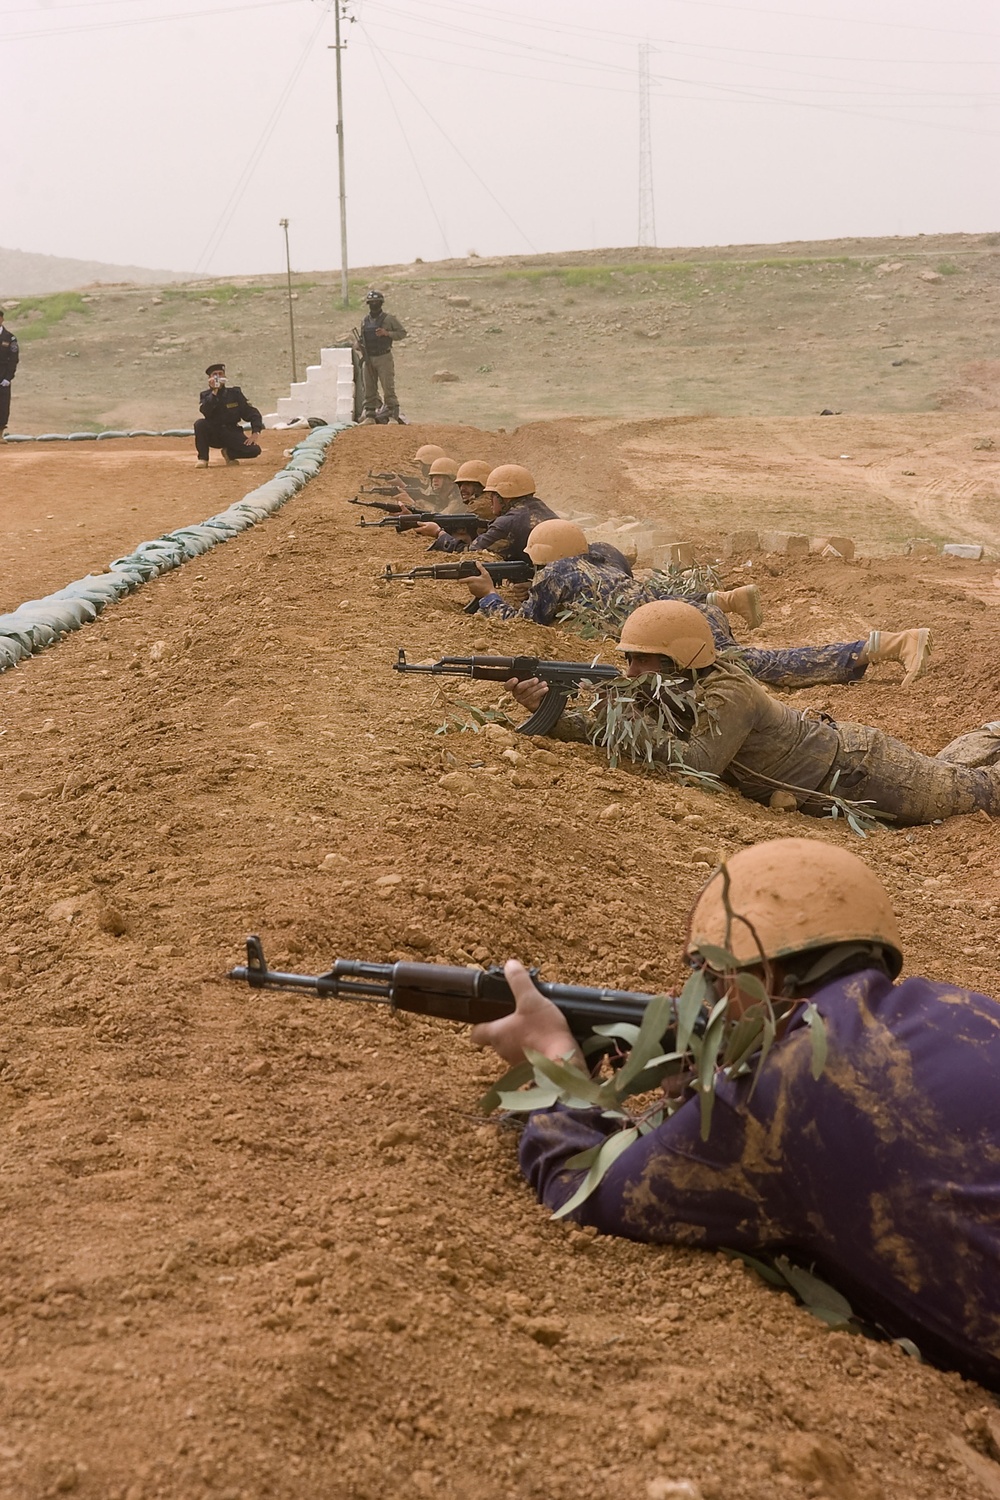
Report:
684,839,903,978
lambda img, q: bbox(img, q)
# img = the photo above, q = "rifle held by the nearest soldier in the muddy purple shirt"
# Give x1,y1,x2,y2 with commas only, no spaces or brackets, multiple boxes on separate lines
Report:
229,935,673,1052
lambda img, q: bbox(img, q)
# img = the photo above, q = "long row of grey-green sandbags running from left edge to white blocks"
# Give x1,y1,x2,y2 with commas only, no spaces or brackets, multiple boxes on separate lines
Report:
0,423,349,672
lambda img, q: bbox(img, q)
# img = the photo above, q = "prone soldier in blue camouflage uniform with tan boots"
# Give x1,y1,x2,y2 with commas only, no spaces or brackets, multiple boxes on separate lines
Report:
468,521,930,687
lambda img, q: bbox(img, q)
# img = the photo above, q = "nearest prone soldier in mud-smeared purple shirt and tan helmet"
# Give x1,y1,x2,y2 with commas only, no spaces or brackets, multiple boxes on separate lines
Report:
472,839,1000,1388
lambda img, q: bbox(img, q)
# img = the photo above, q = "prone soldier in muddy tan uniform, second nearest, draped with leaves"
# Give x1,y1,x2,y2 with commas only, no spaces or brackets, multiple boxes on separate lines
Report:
507,600,1000,825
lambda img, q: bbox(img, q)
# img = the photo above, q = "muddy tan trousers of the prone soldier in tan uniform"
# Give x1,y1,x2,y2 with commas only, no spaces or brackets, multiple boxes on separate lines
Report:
804,723,1000,827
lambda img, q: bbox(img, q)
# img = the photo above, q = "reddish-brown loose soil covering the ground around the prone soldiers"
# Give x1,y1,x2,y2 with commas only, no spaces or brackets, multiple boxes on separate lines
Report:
0,416,1000,1500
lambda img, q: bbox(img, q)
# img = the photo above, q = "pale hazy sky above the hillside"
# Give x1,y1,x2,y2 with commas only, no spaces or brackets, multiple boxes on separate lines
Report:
0,0,1000,276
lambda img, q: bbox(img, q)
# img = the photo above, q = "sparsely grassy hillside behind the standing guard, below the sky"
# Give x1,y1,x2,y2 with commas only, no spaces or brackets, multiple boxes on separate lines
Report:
0,234,1000,432
